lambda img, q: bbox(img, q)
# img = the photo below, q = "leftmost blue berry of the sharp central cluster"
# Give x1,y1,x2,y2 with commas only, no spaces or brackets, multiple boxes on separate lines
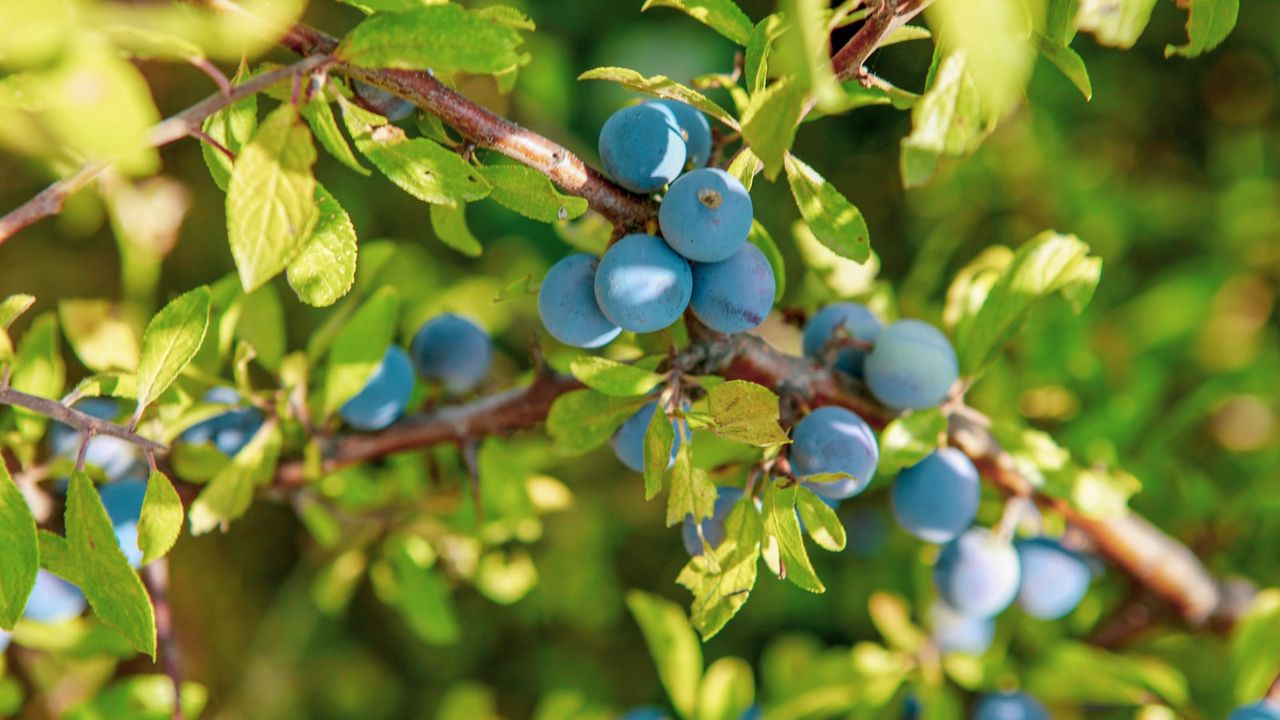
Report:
538,252,622,347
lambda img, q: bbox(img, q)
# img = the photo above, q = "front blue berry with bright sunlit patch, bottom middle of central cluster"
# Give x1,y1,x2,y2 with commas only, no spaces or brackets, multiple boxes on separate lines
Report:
595,234,694,333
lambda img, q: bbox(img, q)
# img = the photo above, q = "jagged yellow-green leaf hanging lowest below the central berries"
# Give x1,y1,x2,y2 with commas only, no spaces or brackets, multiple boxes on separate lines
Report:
676,502,764,641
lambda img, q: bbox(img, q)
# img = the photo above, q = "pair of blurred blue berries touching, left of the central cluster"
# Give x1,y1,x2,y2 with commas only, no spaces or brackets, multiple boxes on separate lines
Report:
339,313,493,430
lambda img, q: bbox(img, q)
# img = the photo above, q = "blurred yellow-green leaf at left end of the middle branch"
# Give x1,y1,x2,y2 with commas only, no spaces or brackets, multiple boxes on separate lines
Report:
187,420,282,536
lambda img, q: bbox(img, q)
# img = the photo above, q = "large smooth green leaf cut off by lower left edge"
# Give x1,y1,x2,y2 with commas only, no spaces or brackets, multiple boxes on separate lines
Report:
0,462,40,630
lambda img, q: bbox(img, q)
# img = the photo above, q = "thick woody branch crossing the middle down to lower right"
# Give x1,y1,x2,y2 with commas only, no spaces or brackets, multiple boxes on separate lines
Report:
278,336,1244,628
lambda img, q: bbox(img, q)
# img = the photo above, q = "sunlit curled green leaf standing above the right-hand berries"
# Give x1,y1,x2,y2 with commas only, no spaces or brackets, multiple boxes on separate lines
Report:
956,231,1102,374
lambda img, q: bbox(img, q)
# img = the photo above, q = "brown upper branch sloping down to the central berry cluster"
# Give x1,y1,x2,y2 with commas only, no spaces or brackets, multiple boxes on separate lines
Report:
266,17,658,231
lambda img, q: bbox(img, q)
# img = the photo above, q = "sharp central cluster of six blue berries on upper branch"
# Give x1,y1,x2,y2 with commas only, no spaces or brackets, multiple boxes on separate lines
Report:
538,100,777,348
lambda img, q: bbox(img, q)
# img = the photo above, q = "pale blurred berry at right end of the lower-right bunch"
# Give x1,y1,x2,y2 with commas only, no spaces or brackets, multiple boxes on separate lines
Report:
1014,537,1093,620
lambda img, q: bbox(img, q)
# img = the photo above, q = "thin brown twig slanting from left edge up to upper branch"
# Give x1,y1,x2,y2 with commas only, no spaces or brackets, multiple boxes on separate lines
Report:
0,55,332,245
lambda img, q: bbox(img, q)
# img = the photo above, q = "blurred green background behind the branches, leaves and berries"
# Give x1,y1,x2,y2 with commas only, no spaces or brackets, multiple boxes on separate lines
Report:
0,0,1280,720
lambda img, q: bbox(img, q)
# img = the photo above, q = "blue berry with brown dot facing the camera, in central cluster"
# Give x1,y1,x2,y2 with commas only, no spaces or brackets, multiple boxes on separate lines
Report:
658,168,753,263
